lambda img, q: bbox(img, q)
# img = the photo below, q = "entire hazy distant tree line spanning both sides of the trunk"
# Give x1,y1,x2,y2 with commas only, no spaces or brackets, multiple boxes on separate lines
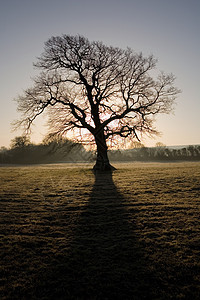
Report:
0,136,200,164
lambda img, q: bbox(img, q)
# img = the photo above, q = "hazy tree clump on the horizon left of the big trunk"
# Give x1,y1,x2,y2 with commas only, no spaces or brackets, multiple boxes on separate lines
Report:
0,136,91,164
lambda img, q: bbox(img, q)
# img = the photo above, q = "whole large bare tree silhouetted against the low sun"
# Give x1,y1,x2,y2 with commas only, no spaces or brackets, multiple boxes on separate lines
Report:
14,35,179,170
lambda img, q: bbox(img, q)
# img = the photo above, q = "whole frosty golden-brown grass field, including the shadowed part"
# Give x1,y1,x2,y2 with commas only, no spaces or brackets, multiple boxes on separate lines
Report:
0,162,200,300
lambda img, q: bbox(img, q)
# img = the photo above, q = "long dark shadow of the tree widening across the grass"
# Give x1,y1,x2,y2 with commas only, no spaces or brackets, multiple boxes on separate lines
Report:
39,173,158,300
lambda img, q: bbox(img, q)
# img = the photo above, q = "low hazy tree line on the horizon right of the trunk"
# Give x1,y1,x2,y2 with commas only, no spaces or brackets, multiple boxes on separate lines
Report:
109,145,200,161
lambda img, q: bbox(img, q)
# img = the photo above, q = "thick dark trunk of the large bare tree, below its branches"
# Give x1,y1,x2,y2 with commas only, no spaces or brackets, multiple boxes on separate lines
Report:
93,130,115,171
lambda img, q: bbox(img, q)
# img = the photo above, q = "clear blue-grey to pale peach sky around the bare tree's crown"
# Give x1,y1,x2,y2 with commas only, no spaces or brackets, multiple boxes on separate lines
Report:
0,0,200,147
